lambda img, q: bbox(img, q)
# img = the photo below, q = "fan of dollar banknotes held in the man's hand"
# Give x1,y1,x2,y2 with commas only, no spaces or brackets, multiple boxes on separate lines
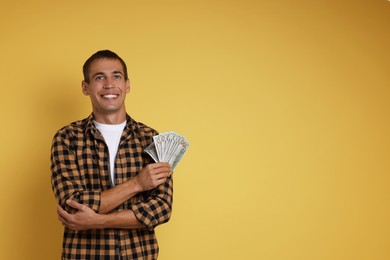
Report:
145,132,190,172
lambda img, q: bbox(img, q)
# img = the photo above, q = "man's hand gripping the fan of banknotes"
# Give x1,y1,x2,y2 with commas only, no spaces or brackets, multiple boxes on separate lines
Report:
135,162,171,191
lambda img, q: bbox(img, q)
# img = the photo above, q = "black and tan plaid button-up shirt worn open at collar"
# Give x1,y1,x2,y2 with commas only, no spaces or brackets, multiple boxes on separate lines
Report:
51,115,173,259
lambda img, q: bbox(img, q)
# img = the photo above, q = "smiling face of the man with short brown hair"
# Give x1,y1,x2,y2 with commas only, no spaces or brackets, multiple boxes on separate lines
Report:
82,59,130,116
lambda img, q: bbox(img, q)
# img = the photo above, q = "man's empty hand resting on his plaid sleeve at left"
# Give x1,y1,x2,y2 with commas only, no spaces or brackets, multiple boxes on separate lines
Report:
57,200,99,231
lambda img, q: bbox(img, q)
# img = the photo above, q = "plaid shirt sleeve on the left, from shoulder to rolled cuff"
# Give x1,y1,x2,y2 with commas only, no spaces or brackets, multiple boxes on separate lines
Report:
51,133,101,213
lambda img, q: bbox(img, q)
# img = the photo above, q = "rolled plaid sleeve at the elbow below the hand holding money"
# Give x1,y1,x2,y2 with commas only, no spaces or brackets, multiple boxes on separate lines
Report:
131,175,173,229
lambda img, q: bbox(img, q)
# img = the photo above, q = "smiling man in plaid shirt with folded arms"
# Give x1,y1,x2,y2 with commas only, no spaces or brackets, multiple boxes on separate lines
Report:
51,50,173,259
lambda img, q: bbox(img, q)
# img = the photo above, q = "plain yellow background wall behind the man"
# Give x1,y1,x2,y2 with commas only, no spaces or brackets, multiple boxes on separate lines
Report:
0,0,390,260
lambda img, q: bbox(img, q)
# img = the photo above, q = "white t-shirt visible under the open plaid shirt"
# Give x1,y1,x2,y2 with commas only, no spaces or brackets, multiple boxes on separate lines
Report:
93,121,126,186
